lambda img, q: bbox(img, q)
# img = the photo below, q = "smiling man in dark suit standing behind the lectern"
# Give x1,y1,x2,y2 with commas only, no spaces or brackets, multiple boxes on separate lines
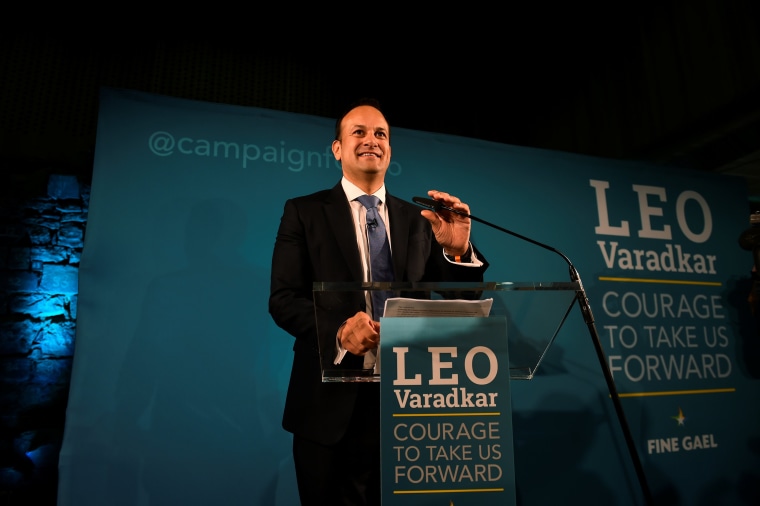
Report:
269,101,488,506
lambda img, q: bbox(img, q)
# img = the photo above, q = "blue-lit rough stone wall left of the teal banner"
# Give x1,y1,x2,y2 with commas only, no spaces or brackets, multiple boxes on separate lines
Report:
0,172,89,505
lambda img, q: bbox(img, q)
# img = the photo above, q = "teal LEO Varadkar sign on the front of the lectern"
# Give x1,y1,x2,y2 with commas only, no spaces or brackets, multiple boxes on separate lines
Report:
380,316,516,506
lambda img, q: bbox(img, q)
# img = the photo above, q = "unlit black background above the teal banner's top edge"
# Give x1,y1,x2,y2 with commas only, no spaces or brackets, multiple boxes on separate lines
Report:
0,0,760,208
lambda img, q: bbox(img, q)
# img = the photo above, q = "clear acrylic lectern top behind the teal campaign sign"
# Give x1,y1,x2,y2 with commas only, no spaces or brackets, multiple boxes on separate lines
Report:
313,281,581,382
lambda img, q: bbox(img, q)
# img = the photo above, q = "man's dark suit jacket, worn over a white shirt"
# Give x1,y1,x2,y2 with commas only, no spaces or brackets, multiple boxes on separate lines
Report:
269,183,488,444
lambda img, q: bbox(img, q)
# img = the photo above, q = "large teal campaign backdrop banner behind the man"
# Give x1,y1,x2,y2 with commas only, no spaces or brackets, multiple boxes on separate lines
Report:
58,88,760,506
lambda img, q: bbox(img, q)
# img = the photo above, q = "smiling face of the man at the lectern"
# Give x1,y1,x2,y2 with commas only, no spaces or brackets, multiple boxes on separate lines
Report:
332,105,391,188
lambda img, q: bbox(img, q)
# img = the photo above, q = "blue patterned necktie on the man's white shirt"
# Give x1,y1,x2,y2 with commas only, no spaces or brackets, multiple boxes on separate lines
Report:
356,195,393,321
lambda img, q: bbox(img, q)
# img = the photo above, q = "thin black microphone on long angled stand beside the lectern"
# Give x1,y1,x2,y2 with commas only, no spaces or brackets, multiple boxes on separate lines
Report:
413,197,654,506
